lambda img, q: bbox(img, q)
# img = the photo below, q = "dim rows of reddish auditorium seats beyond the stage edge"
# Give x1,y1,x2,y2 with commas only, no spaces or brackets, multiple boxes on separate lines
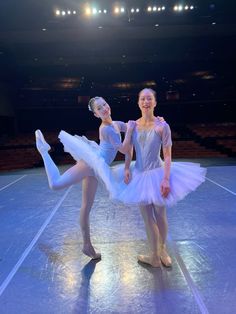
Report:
0,123,236,171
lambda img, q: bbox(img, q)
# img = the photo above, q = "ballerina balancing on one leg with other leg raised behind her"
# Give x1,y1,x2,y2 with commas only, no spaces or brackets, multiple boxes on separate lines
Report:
35,97,136,259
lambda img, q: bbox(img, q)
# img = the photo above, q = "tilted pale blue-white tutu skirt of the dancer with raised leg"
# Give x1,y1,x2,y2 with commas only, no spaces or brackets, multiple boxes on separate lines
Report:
58,131,118,197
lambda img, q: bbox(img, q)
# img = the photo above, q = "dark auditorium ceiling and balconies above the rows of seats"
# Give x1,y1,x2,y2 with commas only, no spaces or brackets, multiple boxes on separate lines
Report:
0,0,236,134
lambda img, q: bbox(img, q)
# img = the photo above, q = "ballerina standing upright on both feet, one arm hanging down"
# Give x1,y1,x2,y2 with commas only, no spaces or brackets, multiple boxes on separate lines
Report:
113,89,206,267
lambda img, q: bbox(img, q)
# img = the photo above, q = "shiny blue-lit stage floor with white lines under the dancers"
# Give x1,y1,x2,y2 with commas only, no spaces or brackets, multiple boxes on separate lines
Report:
0,159,236,314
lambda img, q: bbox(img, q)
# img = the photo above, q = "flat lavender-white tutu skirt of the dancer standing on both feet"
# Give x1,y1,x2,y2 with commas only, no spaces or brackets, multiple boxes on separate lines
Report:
112,162,206,206
